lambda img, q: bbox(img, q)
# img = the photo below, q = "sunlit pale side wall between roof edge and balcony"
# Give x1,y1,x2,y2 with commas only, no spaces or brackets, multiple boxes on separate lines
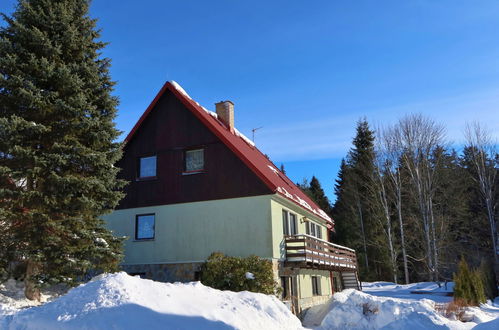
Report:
271,195,328,259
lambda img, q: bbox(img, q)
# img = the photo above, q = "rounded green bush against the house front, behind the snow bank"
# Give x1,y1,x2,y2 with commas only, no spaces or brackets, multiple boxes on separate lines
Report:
201,252,278,294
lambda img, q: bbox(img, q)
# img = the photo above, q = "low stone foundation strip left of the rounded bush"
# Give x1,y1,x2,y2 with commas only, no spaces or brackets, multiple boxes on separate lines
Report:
121,262,202,282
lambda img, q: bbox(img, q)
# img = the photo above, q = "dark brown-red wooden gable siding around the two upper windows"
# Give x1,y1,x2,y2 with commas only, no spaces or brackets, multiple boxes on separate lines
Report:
118,90,273,209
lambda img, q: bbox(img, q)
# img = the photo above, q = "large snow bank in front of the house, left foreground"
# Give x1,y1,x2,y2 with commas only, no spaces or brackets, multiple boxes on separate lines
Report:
0,272,302,330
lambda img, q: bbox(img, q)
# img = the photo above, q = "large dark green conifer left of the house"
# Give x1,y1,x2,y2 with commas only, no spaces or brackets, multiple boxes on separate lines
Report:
0,0,123,299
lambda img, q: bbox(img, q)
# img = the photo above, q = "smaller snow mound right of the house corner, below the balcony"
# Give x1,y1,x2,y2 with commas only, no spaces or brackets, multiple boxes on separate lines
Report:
304,289,476,329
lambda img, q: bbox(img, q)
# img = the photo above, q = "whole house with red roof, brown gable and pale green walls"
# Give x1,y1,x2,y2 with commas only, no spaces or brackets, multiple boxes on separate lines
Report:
105,81,359,312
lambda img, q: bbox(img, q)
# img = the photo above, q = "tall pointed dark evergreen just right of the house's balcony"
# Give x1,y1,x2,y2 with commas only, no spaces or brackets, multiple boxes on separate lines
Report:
333,119,384,279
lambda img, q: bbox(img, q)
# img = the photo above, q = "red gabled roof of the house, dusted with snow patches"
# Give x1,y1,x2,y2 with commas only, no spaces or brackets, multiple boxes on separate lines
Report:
125,81,334,227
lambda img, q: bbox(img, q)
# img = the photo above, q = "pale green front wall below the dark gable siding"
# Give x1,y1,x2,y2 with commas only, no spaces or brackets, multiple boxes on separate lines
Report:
103,195,274,264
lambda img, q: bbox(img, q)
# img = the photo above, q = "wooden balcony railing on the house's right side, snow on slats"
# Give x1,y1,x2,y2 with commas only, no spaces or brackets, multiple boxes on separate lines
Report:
284,234,357,272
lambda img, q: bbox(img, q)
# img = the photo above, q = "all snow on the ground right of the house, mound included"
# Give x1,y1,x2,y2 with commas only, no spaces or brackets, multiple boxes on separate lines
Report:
304,282,499,330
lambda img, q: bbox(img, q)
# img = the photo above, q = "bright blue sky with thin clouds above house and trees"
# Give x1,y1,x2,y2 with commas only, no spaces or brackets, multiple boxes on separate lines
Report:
0,0,499,198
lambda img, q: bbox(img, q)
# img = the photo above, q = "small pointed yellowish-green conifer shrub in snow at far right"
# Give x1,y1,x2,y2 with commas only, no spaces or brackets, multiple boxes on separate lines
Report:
454,258,486,306
